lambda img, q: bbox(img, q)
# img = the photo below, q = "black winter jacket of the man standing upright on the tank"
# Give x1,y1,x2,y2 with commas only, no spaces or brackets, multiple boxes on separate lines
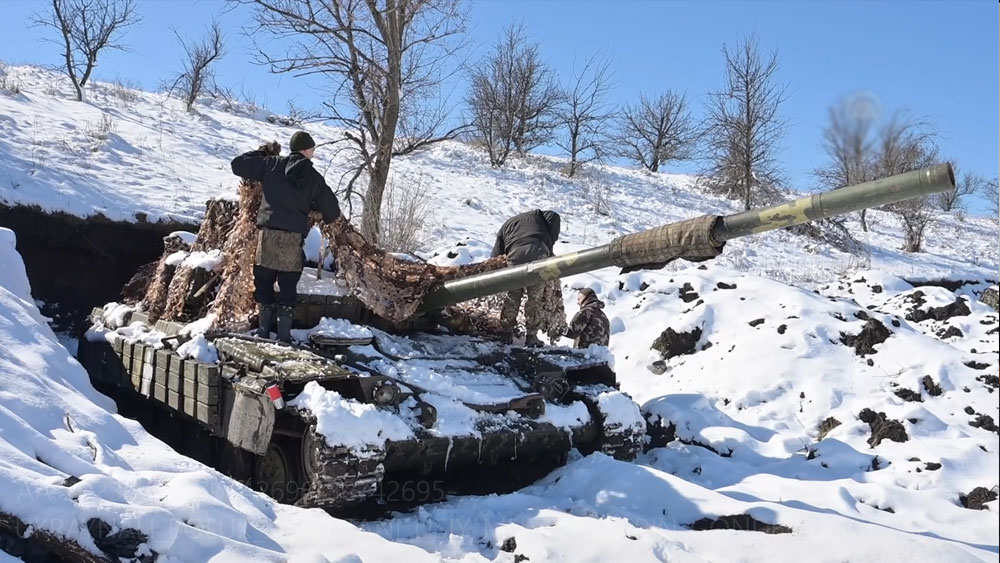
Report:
232,151,340,236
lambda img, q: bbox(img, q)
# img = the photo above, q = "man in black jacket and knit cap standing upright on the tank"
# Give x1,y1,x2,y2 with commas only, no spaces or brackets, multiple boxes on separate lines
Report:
232,131,340,342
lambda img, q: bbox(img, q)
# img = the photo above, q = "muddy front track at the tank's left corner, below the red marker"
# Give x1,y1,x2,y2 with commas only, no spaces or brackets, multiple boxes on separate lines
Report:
295,413,385,508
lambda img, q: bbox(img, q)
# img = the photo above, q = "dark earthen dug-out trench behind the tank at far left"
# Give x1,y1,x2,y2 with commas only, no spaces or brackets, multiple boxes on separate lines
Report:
0,205,198,336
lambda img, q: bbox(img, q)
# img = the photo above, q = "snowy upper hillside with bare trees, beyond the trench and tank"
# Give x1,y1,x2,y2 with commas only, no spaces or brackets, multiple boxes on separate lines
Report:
0,66,1000,285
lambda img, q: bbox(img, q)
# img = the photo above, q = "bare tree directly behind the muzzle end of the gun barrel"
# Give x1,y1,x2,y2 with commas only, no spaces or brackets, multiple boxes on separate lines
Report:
873,112,938,252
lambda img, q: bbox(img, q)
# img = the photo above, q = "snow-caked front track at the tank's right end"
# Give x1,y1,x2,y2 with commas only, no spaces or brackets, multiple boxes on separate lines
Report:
572,385,646,461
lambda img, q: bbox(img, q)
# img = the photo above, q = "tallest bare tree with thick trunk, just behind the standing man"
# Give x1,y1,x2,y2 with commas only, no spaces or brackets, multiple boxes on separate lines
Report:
238,0,465,243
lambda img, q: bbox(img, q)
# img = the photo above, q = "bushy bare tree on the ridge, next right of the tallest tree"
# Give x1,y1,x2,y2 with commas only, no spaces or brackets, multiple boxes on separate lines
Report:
465,23,562,166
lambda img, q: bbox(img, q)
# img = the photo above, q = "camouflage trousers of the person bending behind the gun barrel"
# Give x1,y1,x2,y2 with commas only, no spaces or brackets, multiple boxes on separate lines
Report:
500,280,566,341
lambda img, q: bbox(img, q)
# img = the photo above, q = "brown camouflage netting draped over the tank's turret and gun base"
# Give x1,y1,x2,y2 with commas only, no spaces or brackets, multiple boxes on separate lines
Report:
137,143,566,338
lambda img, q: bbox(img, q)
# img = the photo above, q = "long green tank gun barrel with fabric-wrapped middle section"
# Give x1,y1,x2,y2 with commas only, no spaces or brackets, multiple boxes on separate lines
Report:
419,163,955,311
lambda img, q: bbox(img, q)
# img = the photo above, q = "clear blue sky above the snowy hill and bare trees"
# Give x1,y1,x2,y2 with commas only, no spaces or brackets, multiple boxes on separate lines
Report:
0,0,1000,215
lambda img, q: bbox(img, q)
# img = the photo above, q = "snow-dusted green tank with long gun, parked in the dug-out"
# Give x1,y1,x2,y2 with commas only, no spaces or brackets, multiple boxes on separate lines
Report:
78,164,954,509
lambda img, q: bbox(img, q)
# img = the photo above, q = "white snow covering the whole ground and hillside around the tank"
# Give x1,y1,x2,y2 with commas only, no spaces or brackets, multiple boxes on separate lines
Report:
0,67,1000,561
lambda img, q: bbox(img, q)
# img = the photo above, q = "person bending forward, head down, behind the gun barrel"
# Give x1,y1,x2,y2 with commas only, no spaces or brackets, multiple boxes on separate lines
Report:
490,209,560,346
